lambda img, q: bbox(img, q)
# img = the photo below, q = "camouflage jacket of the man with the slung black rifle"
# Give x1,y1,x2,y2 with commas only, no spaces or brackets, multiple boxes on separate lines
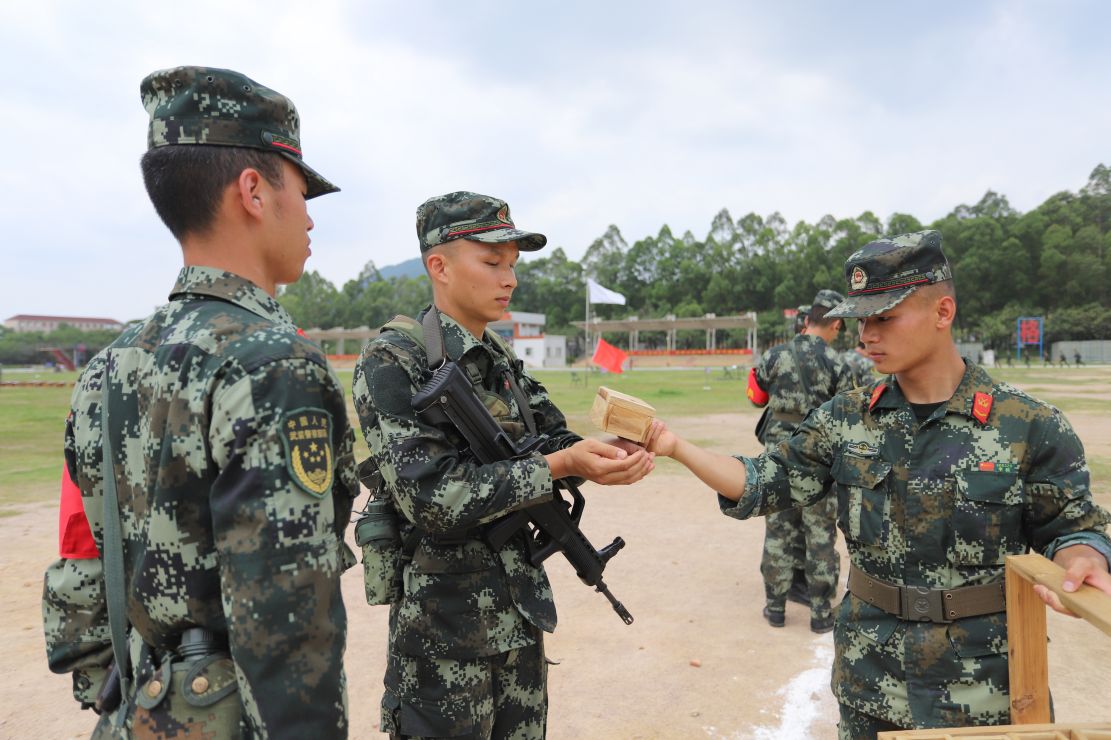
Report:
353,304,580,659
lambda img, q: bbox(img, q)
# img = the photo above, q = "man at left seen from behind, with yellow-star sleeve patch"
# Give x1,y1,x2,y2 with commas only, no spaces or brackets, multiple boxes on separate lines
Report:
42,67,358,738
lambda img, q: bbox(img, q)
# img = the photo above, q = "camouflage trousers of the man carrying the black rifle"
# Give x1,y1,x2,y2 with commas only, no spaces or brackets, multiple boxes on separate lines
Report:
380,636,548,740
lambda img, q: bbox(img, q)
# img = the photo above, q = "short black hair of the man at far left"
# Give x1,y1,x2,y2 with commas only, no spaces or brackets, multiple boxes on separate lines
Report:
140,144,284,236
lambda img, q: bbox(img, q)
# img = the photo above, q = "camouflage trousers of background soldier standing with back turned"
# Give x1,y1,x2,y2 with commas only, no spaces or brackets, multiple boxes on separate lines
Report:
760,496,841,618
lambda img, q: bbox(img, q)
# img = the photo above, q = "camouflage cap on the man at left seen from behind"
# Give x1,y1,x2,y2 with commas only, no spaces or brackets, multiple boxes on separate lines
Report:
139,67,339,198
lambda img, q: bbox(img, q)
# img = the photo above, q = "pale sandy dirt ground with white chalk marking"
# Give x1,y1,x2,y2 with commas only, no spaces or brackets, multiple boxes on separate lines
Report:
0,388,1111,740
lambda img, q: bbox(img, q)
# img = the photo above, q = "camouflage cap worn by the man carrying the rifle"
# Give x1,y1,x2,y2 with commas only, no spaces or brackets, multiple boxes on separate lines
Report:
417,190,548,253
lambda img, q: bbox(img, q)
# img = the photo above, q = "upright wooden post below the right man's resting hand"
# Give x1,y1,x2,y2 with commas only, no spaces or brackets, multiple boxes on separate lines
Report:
1007,556,1050,724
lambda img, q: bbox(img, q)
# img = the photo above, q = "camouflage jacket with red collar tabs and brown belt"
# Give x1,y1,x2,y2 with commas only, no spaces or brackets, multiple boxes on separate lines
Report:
719,363,1111,727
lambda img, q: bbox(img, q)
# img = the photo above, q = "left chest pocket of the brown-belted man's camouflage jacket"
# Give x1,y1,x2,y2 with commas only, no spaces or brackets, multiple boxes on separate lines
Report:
830,454,891,544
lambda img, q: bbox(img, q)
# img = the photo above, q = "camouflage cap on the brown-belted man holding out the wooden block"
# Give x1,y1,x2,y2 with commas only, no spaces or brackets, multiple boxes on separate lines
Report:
825,230,953,319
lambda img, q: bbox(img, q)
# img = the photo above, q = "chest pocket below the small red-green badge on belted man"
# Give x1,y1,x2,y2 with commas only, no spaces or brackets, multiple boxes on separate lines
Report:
950,470,1025,566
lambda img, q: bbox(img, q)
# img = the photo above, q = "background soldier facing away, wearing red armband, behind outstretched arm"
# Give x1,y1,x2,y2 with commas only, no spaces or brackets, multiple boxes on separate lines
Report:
748,290,852,632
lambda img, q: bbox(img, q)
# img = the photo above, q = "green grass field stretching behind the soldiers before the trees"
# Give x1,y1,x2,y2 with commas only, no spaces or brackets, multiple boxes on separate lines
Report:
0,367,1111,517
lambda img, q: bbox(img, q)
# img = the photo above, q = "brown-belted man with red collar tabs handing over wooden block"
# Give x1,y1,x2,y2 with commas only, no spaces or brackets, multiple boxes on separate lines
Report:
648,231,1111,738
